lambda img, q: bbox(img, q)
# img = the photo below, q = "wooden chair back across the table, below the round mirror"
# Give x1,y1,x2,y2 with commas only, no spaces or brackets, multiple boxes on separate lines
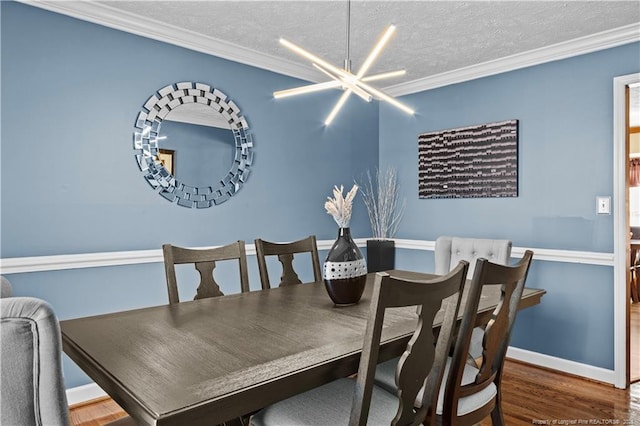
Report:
162,241,249,303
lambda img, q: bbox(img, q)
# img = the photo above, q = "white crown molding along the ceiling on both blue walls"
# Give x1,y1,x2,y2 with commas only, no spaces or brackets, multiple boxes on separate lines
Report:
18,0,640,96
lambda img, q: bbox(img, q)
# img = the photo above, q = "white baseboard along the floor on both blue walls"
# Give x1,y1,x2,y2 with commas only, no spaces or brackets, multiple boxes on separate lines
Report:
67,346,614,405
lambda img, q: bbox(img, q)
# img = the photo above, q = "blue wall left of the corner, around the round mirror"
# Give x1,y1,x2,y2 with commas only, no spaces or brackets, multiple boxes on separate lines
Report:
0,1,378,387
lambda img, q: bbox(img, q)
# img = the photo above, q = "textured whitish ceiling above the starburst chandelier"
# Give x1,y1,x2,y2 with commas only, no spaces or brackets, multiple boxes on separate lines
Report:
96,0,640,85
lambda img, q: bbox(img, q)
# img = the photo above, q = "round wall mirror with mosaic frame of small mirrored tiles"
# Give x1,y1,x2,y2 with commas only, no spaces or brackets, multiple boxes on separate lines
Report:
134,82,253,208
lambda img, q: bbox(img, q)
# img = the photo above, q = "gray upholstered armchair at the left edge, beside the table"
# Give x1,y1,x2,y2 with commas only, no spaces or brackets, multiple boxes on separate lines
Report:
0,277,69,426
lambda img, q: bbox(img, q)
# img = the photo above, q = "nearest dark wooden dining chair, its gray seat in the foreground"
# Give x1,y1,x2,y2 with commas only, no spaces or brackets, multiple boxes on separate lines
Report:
251,261,469,426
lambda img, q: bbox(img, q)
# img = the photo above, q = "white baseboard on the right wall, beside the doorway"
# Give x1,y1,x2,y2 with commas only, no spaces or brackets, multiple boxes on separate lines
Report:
507,346,615,385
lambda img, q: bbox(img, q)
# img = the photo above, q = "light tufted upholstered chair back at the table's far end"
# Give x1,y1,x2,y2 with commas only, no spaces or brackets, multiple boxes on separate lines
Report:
435,237,511,278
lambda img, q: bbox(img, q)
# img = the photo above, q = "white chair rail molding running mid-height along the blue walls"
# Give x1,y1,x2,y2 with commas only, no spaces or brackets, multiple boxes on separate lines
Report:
0,238,614,275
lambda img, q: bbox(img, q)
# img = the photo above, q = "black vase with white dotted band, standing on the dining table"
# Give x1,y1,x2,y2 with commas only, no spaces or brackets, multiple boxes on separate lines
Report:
324,228,367,306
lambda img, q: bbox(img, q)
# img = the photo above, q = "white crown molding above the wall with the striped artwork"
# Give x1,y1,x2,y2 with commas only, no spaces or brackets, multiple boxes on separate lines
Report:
385,23,640,96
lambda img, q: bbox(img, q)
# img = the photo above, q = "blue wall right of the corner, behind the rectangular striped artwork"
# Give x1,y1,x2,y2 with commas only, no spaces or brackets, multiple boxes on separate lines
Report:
380,43,640,369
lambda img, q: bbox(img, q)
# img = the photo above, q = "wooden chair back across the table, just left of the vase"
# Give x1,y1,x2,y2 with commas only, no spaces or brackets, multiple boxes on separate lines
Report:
255,235,322,290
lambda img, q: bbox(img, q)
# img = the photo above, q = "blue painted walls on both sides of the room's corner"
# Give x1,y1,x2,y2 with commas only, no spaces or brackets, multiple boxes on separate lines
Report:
0,2,640,387
